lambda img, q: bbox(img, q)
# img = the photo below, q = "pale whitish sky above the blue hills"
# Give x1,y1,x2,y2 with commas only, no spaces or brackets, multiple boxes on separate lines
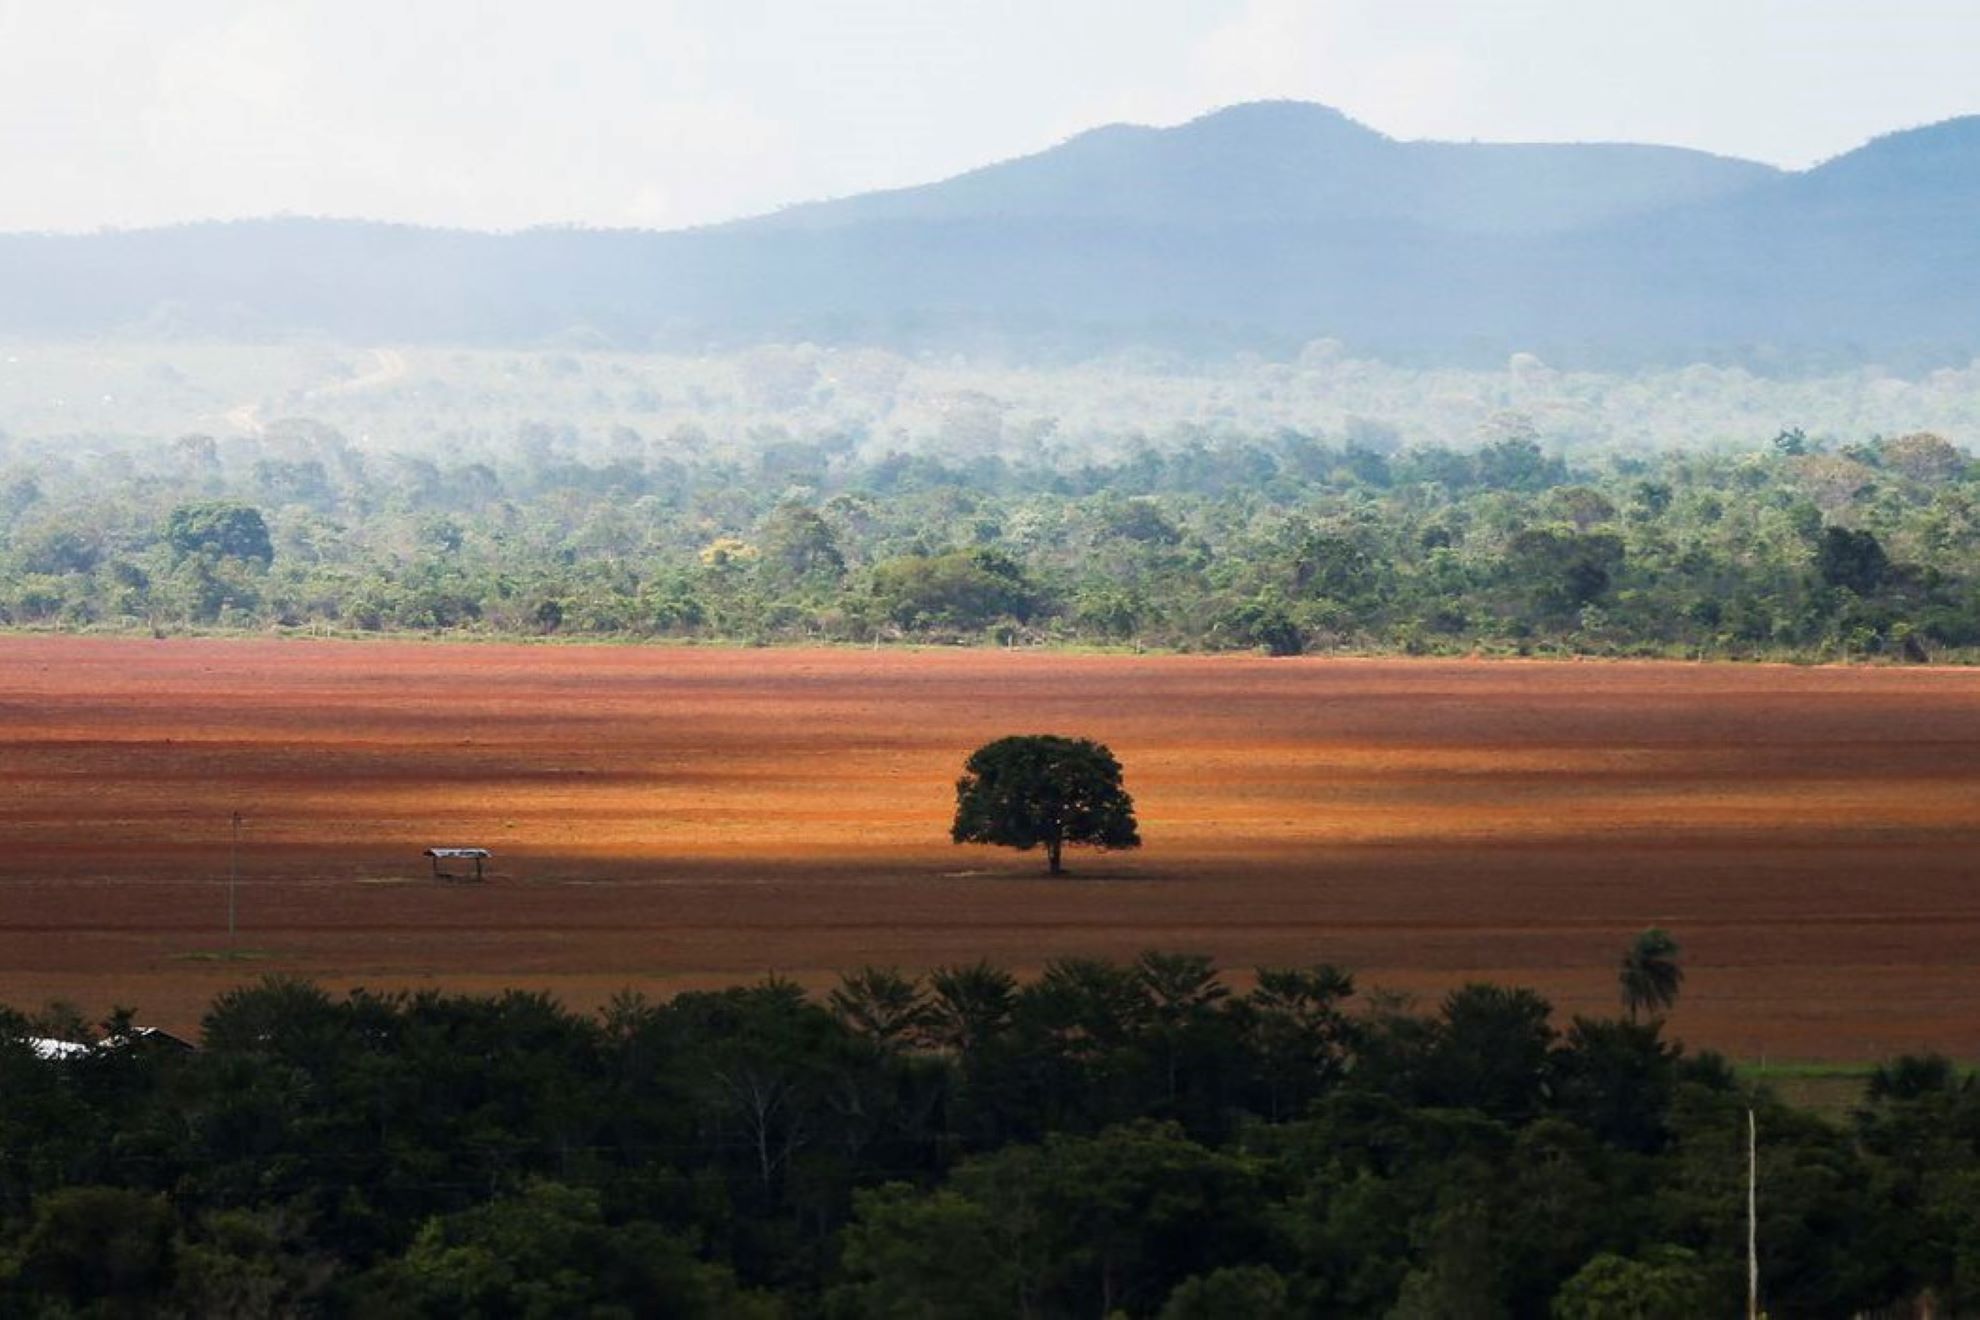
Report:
0,0,1980,232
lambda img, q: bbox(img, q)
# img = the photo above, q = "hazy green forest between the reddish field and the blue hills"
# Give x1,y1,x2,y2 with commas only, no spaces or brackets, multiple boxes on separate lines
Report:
0,344,1980,659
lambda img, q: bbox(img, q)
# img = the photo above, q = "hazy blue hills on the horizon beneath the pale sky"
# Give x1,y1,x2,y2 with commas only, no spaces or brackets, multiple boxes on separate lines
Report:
0,103,1980,366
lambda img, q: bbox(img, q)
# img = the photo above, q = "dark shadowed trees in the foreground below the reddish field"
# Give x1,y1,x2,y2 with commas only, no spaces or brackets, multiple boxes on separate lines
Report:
0,953,1980,1320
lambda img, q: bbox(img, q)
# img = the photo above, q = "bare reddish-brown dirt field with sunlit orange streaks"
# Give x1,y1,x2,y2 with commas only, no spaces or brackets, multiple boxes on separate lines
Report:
0,637,1980,1059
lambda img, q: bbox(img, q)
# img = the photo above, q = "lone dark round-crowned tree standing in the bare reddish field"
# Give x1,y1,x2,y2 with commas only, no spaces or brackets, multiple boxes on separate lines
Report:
948,734,1140,875
